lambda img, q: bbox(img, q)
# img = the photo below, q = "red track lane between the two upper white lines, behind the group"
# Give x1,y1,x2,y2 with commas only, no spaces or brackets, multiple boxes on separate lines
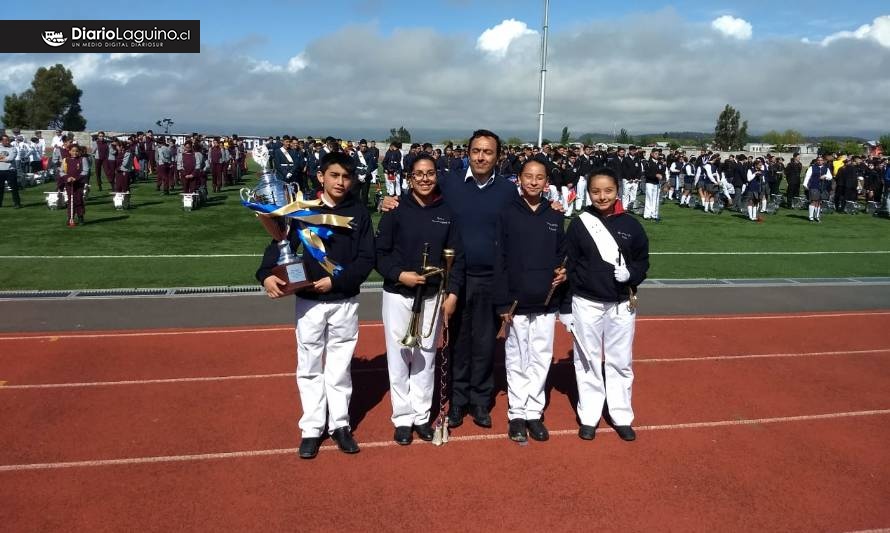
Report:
0,313,890,385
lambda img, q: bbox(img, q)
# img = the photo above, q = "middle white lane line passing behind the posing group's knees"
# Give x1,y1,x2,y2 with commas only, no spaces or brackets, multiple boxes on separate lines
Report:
0,348,890,392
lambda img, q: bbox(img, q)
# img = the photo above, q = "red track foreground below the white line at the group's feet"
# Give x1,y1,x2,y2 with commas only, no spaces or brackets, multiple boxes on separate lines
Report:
0,416,890,532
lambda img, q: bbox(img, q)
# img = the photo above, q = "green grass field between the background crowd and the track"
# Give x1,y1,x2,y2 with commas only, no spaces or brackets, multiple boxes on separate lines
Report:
0,167,890,290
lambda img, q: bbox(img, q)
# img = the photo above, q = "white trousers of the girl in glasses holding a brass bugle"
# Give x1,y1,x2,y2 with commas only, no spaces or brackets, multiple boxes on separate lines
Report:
383,291,442,427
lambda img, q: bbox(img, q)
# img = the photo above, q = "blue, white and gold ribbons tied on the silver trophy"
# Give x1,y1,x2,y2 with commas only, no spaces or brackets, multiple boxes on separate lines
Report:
241,173,352,276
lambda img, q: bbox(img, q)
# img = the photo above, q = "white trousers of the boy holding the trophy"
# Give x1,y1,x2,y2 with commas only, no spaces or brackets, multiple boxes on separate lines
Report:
296,297,358,437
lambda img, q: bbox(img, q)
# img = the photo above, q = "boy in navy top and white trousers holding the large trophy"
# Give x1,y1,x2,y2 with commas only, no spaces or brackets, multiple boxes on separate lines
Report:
256,152,375,459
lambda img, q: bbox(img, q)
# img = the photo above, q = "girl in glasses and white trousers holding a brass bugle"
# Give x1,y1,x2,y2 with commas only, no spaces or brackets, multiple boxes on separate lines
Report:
376,153,464,445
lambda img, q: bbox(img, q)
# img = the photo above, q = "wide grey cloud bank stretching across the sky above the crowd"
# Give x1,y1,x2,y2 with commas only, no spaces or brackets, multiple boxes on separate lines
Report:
0,15,890,142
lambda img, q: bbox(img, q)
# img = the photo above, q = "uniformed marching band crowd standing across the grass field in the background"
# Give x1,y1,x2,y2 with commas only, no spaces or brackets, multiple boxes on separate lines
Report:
0,124,890,222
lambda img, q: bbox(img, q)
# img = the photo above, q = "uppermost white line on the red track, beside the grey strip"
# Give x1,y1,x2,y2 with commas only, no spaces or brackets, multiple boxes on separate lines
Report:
0,311,890,341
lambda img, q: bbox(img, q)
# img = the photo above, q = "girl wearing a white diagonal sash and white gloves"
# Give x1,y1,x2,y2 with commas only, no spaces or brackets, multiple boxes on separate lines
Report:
560,168,649,441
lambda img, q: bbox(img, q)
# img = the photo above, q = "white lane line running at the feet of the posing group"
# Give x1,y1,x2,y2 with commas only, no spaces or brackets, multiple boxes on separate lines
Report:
0,409,890,472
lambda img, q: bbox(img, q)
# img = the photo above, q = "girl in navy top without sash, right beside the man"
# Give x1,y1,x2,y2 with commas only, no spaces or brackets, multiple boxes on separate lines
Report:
493,159,566,442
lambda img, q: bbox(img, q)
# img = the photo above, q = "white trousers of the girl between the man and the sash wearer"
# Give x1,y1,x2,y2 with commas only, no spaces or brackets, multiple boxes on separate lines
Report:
504,313,556,420
